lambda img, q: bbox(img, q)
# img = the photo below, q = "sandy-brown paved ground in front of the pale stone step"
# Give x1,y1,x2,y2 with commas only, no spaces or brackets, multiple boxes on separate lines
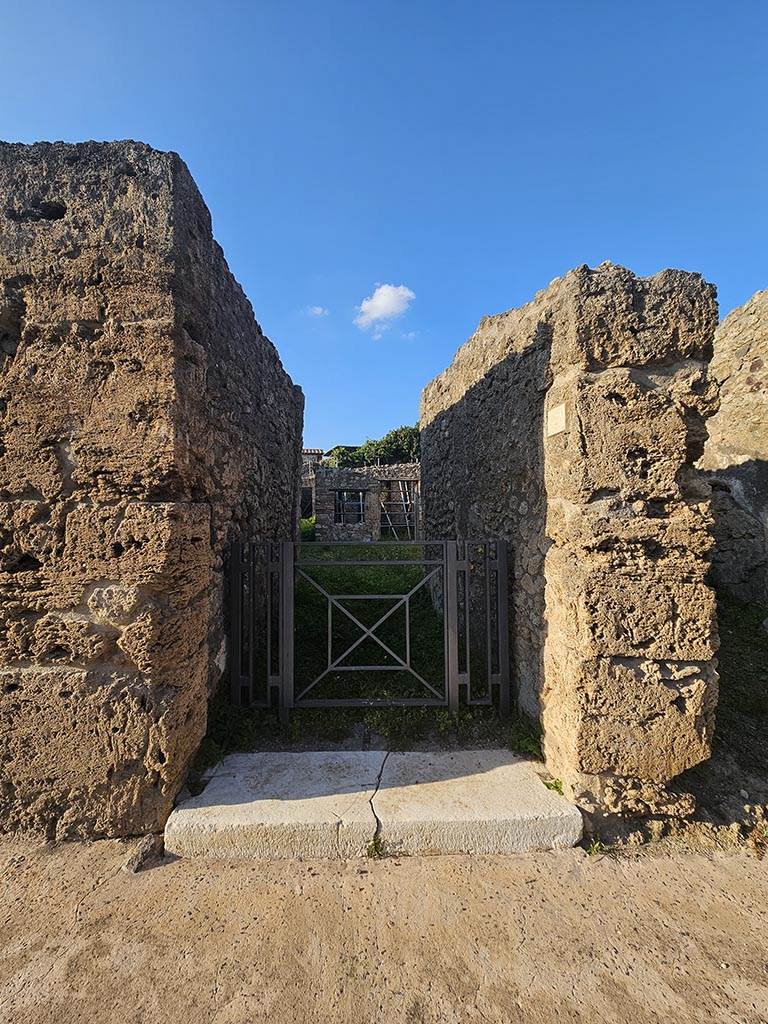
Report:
0,842,768,1024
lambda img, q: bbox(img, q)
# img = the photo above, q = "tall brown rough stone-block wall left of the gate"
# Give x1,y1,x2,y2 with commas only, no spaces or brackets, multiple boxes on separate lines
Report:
0,142,302,837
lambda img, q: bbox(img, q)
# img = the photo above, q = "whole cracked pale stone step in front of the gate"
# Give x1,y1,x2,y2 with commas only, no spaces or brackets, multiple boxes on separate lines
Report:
165,750,582,860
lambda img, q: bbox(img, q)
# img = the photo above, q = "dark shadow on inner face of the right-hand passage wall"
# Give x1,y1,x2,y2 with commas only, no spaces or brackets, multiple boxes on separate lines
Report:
422,323,552,718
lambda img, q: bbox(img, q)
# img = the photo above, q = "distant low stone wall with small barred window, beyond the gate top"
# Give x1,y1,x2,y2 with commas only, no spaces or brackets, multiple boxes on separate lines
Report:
314,462,421,542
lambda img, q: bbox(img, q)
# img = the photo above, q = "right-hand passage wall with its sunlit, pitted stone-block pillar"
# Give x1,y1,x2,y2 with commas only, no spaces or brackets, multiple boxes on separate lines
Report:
422,264,717,813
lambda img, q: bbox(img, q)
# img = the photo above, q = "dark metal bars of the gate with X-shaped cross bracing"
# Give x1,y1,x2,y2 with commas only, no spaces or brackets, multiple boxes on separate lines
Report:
228,540,511,721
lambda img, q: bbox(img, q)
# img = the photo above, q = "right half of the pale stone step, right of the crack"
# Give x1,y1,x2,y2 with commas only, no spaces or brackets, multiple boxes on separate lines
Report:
374,750,582,855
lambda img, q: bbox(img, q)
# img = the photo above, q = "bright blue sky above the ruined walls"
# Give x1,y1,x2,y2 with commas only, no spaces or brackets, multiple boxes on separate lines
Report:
0,0,768,446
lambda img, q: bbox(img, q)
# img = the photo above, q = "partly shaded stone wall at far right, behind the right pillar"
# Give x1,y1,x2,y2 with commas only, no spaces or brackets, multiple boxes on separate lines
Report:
699,291,768,605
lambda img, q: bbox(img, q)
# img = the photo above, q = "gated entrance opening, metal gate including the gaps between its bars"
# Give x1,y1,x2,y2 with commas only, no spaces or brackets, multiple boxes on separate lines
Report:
229,541,510,720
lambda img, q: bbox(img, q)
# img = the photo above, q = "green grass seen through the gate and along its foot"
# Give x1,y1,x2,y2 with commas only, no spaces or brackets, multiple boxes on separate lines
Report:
194,540,543,774
